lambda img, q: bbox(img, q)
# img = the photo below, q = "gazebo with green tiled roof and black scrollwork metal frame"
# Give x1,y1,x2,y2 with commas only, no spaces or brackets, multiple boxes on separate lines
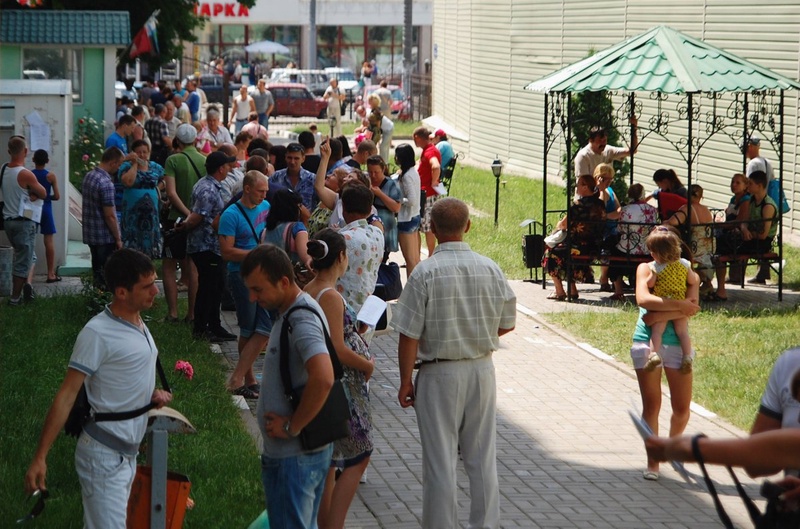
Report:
525,26,800,301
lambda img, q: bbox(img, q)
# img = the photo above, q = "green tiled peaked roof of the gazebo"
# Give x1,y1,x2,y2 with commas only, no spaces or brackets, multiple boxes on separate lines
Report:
525,26,800,94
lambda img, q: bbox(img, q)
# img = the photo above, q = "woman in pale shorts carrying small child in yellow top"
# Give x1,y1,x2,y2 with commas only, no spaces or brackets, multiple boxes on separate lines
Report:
631,226,700,481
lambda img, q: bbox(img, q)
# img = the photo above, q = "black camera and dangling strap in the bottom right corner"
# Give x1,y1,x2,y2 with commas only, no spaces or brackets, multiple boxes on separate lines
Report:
692,434,800,529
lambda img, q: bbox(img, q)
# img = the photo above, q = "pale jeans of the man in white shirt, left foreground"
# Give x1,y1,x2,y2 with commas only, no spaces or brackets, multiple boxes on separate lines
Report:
75,432,136,529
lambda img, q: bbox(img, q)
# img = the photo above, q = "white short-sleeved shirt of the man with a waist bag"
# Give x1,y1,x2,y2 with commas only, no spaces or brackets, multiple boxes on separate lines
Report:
69,307,158,444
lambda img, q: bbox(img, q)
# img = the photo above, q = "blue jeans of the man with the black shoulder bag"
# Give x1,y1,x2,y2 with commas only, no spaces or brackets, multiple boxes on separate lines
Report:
261,444,333,529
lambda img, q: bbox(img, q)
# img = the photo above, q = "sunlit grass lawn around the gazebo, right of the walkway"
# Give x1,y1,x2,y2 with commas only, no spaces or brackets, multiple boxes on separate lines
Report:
451,165,800,430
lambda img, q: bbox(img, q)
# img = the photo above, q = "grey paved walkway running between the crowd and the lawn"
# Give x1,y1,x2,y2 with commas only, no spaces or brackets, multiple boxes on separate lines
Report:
209,281,798,529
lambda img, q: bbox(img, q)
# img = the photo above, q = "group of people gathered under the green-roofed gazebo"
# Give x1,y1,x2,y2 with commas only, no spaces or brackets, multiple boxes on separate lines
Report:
542,126,785,302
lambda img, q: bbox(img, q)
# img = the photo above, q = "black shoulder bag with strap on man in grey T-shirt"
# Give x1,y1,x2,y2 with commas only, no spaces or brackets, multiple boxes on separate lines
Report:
280,305,352,450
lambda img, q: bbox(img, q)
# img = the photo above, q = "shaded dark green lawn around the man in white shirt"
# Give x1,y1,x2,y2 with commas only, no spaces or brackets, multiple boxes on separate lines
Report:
0,295,264,528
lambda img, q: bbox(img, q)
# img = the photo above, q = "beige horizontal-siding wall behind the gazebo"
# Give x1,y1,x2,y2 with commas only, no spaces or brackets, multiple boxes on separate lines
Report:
433,0,800,234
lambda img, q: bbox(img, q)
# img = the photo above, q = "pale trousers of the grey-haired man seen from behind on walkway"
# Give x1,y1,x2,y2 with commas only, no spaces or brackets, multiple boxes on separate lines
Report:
414,355,500,529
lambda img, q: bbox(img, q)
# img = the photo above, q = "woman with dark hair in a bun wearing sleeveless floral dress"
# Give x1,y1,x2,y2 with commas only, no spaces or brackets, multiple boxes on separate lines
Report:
305,228,375,529
